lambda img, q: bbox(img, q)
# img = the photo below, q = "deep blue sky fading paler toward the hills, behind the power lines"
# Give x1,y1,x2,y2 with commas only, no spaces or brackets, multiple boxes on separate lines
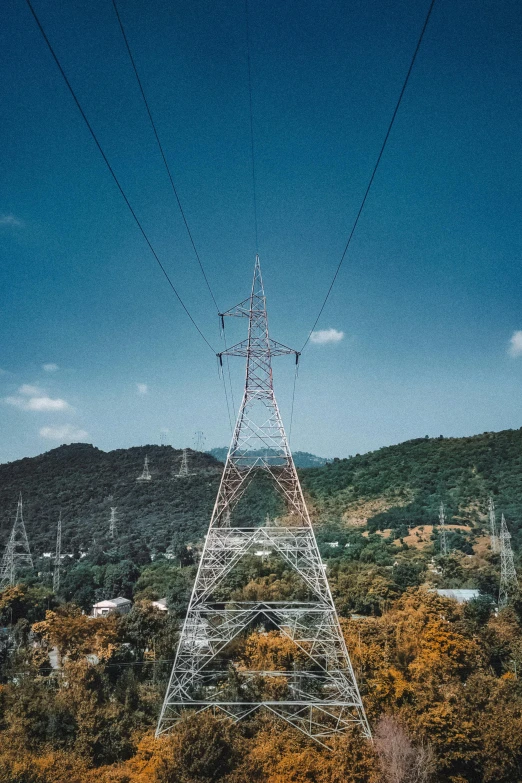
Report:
0,0,522,461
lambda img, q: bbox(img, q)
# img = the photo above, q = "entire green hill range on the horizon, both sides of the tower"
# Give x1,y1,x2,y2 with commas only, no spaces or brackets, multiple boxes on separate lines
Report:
0,430,522,553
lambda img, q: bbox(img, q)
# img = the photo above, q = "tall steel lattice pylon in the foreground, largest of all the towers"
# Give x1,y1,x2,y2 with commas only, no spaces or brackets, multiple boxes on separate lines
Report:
157,256,371,745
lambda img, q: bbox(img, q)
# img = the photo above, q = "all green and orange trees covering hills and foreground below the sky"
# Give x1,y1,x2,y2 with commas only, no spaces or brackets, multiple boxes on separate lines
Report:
0,431,522,783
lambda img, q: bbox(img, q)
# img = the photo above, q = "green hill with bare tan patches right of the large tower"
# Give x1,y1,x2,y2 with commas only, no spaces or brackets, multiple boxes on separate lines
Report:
301,429,522,548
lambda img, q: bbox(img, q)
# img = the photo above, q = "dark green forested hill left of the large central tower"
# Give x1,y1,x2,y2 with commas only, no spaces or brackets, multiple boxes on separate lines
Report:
0,443,222,554
